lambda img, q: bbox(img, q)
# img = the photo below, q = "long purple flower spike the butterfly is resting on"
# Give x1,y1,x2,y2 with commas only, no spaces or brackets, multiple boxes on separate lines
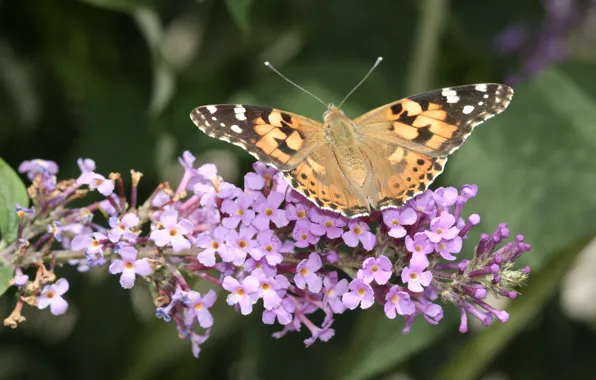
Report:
5,152,530,356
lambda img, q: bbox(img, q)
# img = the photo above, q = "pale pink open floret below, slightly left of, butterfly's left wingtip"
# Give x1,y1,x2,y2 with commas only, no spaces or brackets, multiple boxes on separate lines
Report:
149,210,194,252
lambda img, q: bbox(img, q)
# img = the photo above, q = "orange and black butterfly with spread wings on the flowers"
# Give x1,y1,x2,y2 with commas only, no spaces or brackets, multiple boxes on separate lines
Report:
190,83,513,218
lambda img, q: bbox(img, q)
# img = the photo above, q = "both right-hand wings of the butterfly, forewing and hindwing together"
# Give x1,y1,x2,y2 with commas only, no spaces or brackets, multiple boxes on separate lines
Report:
354,84,513,209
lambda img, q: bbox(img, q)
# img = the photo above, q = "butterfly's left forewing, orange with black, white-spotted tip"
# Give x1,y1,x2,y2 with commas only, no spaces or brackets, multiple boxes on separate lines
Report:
190,104,323,171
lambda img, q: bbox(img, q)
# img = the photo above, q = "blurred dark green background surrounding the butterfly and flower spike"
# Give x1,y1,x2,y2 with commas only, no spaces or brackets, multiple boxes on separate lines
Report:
0,0,596,380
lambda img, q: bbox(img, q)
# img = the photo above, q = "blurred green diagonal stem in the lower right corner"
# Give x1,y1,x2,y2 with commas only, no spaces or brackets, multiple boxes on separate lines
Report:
437,234,596,380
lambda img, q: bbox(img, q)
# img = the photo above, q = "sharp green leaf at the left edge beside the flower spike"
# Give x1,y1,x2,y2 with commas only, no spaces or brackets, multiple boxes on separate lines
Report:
0,158,29,243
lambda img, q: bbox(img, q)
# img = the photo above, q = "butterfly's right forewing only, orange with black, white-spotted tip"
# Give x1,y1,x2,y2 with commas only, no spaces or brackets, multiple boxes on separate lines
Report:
354,83,513,157
